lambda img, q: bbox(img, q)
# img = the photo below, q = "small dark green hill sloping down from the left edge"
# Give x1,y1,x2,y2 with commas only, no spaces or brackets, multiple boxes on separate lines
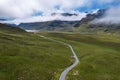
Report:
0,23,25,33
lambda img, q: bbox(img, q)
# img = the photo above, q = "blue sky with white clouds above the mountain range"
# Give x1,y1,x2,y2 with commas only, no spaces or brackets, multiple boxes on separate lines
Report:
0,0,120,24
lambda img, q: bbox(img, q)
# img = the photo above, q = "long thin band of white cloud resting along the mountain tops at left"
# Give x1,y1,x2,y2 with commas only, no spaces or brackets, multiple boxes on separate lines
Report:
1,12,86,25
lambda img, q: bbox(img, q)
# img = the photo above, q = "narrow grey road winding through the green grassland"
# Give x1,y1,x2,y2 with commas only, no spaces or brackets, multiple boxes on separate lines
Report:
40,35,79,80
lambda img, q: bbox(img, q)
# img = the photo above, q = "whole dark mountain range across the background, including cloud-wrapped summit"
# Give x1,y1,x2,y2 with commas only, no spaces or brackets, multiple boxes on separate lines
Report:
18,9,120,33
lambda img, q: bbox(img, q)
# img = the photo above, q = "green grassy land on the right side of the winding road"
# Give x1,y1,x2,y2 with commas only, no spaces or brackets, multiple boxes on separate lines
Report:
43,33,120,80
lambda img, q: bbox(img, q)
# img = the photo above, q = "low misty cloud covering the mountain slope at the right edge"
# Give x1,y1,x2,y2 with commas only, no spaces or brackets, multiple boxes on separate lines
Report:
92,6,120,24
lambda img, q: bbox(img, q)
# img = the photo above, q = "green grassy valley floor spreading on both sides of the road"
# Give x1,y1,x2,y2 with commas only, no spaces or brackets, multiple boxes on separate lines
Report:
0,25,120,80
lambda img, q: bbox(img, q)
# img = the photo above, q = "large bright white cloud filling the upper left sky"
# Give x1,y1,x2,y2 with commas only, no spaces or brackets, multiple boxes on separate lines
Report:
0,0,85,18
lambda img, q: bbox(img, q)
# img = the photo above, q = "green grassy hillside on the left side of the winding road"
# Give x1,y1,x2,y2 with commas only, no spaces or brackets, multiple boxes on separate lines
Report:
0,25,73,80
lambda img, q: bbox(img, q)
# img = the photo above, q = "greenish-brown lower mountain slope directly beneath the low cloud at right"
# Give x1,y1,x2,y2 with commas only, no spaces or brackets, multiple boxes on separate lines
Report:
75,22,120,34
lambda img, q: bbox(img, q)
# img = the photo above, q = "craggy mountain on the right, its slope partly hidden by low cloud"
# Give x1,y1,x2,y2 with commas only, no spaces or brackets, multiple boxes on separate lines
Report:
76,9,120,33
